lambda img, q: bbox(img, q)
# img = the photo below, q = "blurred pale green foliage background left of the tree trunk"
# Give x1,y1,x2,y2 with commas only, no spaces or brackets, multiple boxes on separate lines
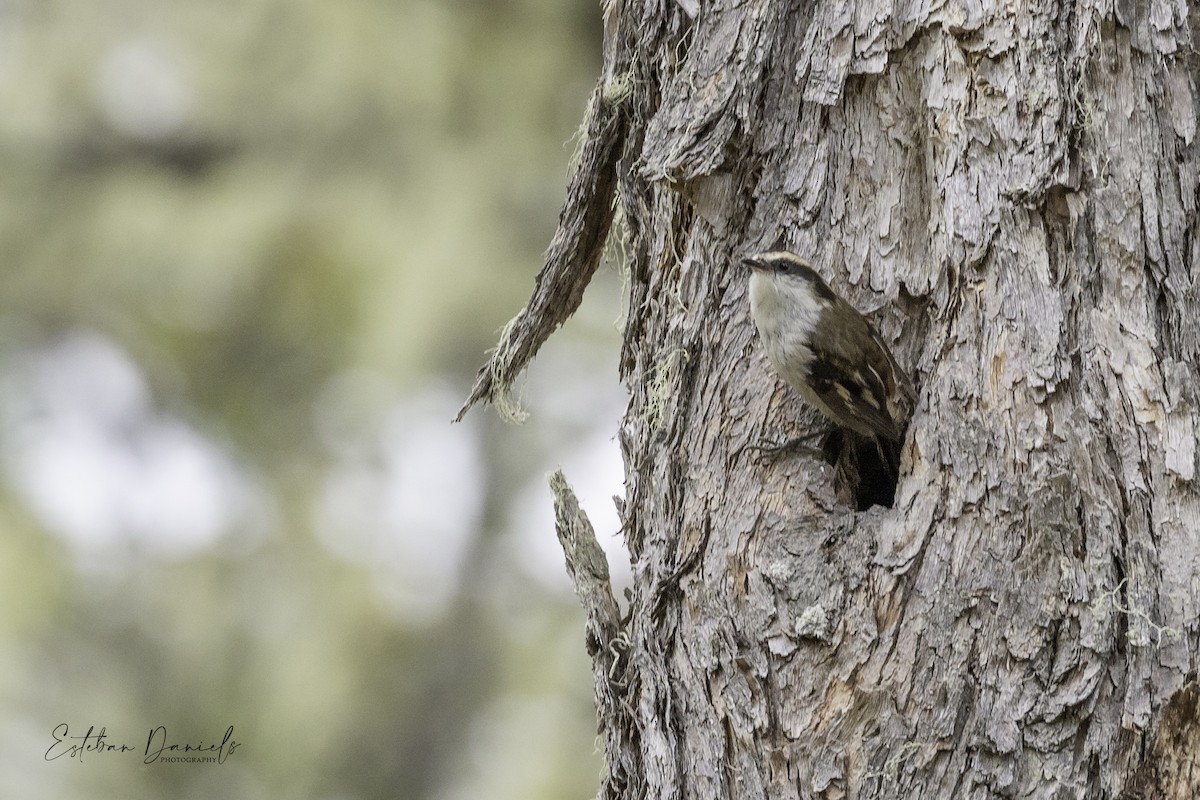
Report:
0,0,617,800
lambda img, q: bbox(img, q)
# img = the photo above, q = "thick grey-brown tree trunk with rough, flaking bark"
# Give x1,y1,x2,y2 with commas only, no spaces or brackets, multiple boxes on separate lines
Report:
460,0,1200,800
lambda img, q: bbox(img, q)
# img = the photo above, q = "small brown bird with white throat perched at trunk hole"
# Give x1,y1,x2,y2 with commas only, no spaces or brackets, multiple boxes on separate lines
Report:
743,251,917,443
